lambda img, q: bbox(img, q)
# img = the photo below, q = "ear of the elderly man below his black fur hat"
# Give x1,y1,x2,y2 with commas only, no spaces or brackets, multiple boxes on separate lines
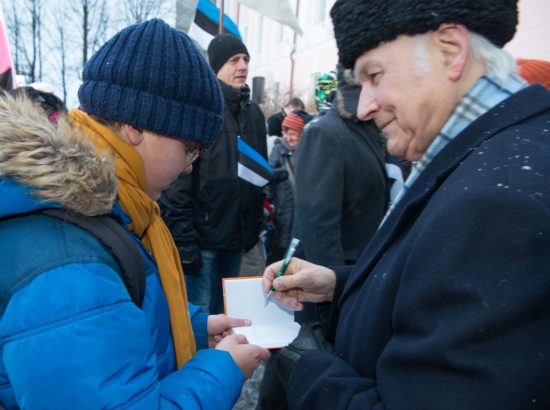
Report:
434,24,470,81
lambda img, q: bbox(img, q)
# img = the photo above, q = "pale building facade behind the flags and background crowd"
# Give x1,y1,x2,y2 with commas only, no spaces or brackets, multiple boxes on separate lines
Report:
223,0,550,113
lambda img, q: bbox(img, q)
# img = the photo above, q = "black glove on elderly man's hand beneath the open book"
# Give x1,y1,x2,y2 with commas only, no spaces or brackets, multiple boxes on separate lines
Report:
277,322,334,390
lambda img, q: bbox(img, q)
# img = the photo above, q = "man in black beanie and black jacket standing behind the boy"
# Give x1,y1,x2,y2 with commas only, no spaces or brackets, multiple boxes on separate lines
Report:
160,34,267,313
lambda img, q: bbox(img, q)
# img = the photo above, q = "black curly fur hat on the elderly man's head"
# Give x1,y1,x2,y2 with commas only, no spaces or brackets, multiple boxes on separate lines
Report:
330,0,518,68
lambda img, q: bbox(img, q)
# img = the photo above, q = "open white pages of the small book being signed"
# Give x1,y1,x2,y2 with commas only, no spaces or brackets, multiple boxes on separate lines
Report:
223,277,300,348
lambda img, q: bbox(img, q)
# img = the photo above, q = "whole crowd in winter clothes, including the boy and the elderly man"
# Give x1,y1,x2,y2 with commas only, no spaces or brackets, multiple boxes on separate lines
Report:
0,0,550,410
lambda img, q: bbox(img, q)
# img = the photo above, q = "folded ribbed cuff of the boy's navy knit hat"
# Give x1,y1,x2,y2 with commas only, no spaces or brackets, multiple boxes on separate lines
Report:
78,80,223,148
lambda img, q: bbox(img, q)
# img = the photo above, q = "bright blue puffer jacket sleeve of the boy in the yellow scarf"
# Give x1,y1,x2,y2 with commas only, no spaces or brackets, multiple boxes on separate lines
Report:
0,263,243,409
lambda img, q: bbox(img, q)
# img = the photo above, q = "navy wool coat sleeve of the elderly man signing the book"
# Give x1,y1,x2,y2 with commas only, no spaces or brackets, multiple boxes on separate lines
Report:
288,187,550,410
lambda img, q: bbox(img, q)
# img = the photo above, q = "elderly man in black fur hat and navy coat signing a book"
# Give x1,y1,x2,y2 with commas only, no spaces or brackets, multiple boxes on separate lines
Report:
264,0,550,409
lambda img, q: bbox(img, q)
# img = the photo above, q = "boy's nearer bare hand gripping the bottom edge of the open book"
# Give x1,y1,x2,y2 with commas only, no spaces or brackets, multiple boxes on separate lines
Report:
216,335,269,380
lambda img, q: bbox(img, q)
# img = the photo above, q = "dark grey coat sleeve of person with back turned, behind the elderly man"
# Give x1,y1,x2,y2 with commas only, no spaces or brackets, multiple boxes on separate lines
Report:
293,126,345,265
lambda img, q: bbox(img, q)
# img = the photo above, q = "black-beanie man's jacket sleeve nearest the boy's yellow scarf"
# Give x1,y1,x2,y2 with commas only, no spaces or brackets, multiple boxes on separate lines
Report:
159,174,201,273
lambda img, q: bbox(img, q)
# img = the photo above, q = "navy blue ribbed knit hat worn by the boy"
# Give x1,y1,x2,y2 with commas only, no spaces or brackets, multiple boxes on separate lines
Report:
78,19,223,148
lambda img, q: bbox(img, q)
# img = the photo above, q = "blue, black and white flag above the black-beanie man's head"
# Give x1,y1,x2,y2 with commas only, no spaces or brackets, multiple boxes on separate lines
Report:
188,0,241,50
